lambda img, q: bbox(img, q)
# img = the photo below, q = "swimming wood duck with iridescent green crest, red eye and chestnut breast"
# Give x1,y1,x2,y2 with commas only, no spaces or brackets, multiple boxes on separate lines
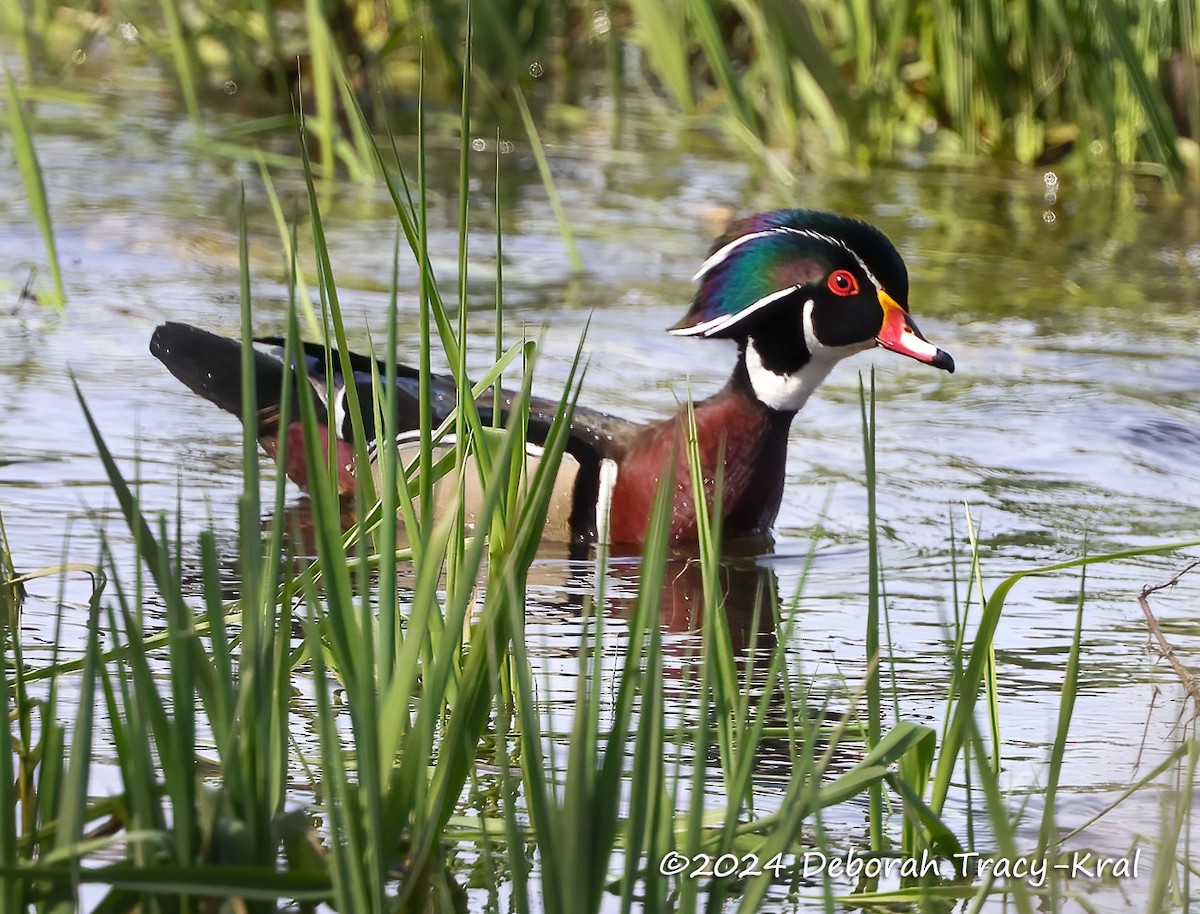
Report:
150,210,954,546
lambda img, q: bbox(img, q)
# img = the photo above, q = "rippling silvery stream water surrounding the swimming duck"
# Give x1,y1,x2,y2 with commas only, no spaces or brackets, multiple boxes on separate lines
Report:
0,47,1200,910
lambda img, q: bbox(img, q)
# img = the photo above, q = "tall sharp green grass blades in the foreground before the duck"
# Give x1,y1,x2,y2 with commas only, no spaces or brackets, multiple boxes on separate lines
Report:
0,112,1196,912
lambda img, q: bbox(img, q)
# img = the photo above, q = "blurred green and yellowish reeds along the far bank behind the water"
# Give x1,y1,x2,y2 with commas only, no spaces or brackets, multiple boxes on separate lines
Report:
9,0,1200,182
